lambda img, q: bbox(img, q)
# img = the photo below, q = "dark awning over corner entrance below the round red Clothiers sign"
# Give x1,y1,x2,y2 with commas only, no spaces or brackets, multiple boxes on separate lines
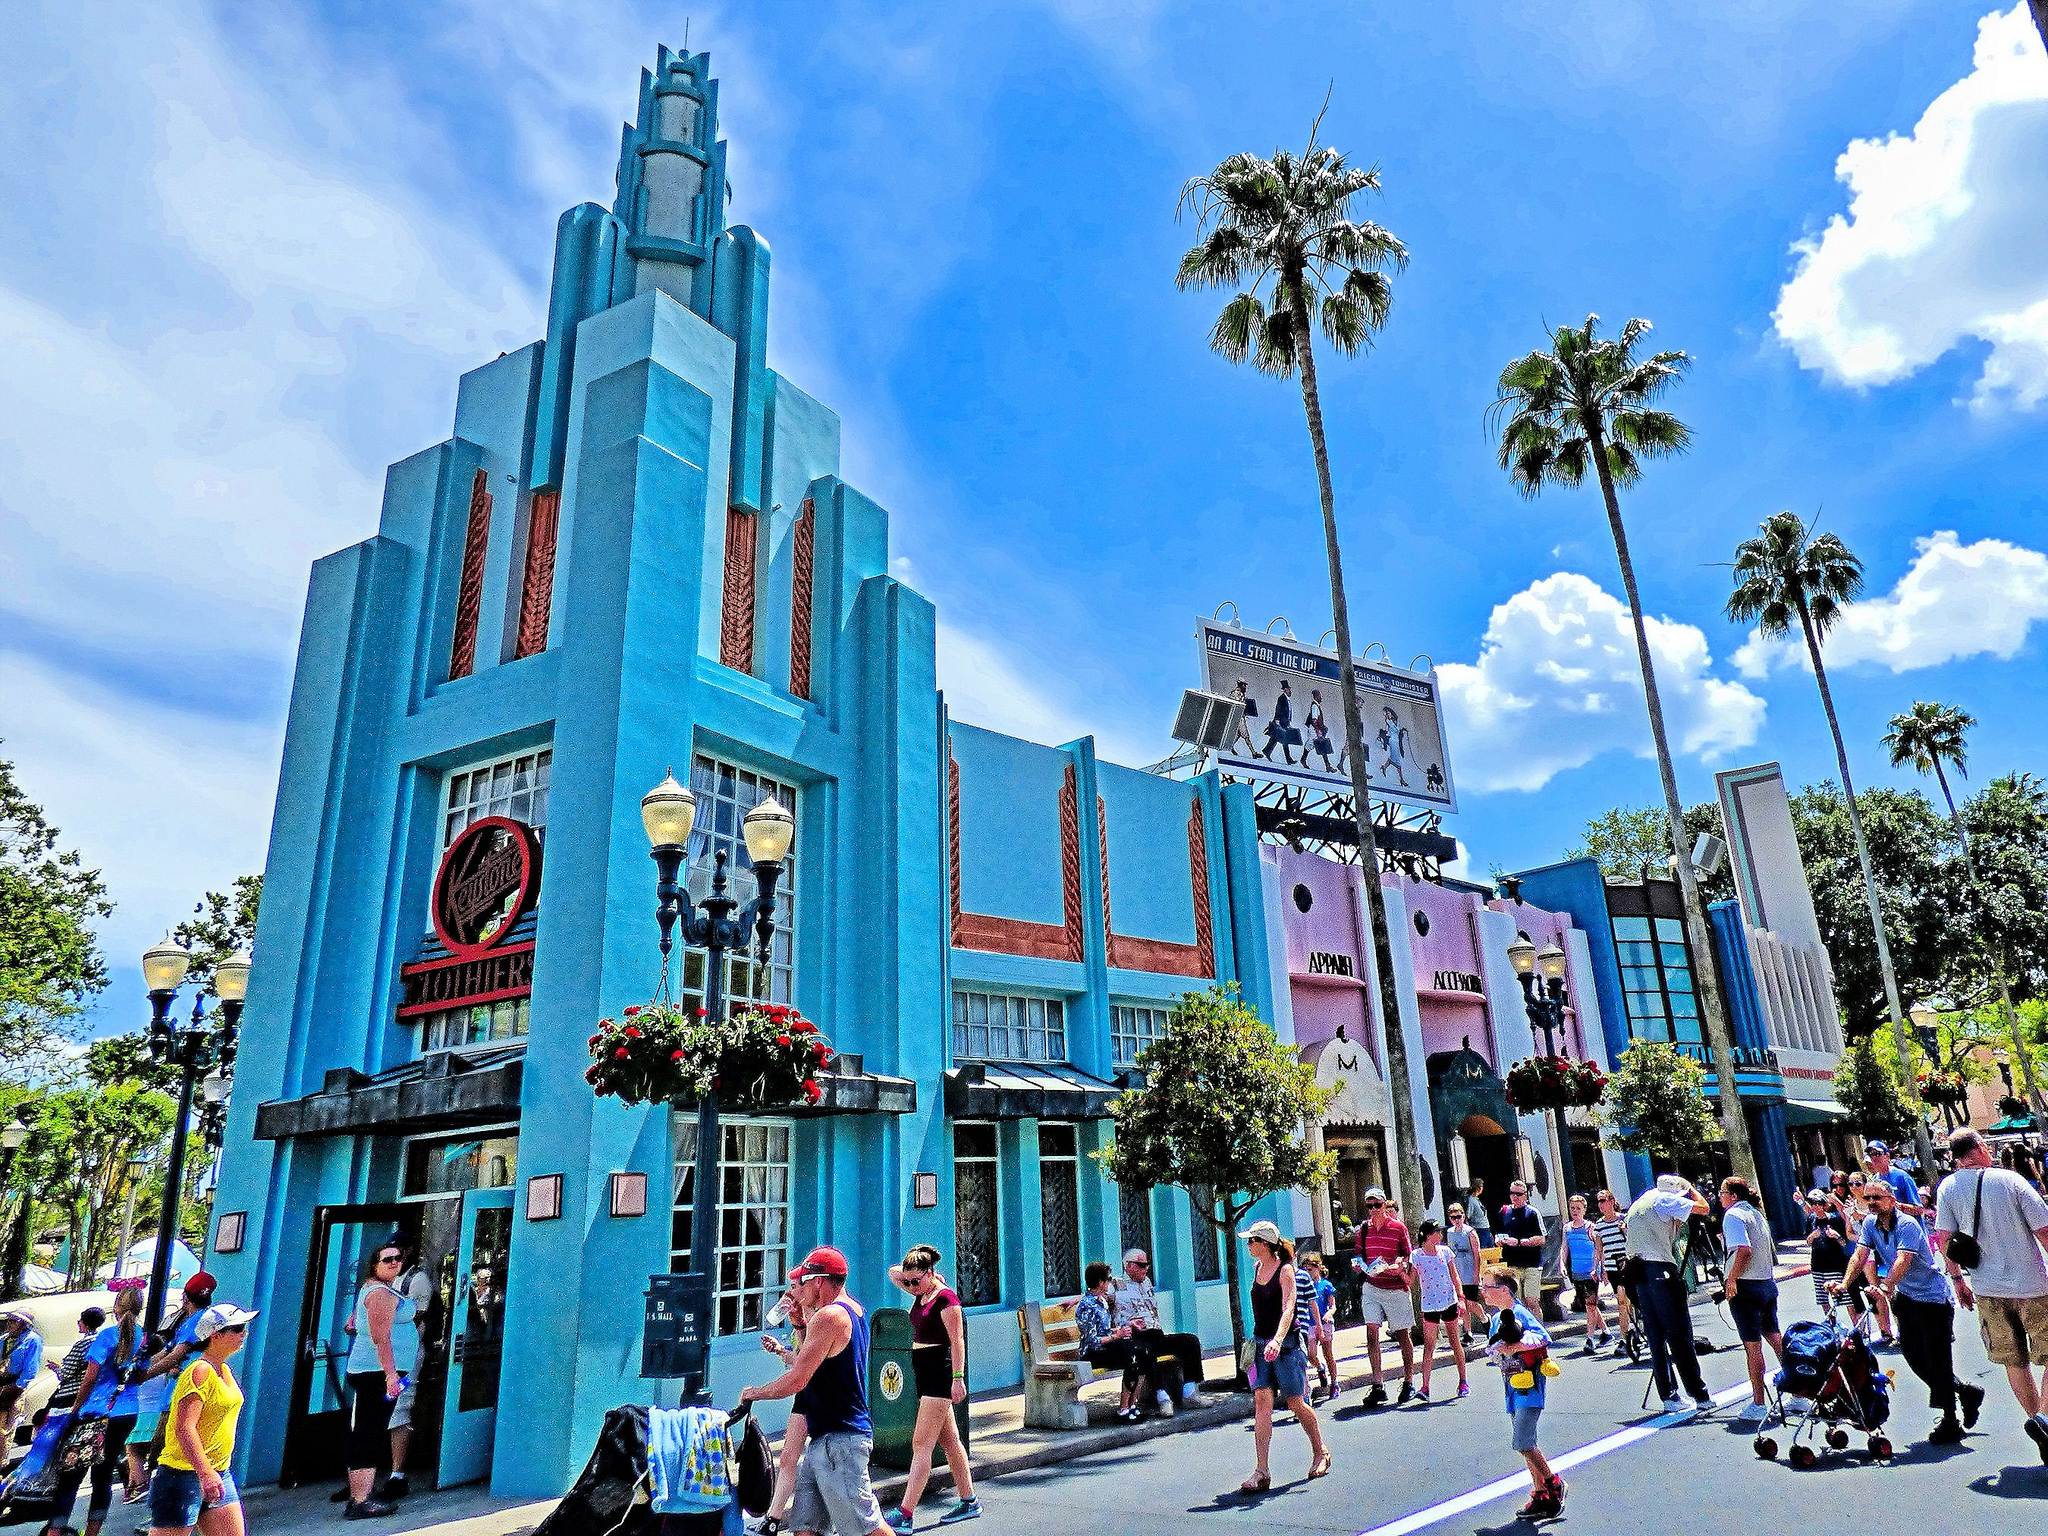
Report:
256,1044,526,1141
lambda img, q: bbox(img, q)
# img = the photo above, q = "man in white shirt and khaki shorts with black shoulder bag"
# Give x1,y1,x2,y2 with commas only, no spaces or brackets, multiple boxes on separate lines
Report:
1933,1130,2048,1462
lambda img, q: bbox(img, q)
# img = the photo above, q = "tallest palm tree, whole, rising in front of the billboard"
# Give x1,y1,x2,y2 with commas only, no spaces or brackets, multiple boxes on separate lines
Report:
1176,115,1430,1210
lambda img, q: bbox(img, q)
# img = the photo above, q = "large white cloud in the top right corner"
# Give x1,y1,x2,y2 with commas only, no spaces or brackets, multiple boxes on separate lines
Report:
1772,0,2048,408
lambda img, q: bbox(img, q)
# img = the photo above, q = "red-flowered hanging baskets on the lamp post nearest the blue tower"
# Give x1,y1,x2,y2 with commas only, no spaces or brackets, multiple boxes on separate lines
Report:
584,1004,834,1110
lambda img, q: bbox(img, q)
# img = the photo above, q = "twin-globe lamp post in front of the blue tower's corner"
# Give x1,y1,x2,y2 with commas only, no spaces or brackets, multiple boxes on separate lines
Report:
641,772,797,1401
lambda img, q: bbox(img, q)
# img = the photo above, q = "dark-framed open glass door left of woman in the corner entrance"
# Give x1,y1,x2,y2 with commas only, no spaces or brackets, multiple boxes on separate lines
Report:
279,1204,414,1487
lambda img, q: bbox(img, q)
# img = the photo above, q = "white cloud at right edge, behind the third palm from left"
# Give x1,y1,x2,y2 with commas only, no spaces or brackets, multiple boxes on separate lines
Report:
1733,530,2048,678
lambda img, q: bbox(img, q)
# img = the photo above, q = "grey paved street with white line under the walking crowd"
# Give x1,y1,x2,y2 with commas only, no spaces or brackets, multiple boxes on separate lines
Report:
962,1280,2048,1536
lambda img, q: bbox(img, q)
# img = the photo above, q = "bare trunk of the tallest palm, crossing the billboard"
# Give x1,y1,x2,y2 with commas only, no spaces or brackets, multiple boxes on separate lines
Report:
1288,282,1430,1214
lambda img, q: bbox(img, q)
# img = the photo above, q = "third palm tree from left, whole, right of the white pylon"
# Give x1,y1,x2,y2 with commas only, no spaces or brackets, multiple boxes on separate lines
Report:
1729,512,1933,1169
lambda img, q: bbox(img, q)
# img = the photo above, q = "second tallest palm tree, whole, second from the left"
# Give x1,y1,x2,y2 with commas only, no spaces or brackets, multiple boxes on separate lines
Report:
1487,315,1757,1184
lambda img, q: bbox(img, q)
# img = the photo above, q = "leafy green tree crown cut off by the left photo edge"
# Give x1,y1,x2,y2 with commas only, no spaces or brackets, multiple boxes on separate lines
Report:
0,762,113,1073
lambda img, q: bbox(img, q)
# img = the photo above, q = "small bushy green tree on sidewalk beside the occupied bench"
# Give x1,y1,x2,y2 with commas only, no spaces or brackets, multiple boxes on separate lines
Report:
1096,983,1337,1376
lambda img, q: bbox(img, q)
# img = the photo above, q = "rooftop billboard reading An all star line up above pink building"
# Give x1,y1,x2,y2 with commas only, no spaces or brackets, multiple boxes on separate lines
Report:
1198,618,1458,811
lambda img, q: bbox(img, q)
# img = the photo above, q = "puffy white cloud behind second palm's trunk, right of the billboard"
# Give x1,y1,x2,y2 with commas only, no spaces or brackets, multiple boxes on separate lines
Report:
1438,571,1763,791
